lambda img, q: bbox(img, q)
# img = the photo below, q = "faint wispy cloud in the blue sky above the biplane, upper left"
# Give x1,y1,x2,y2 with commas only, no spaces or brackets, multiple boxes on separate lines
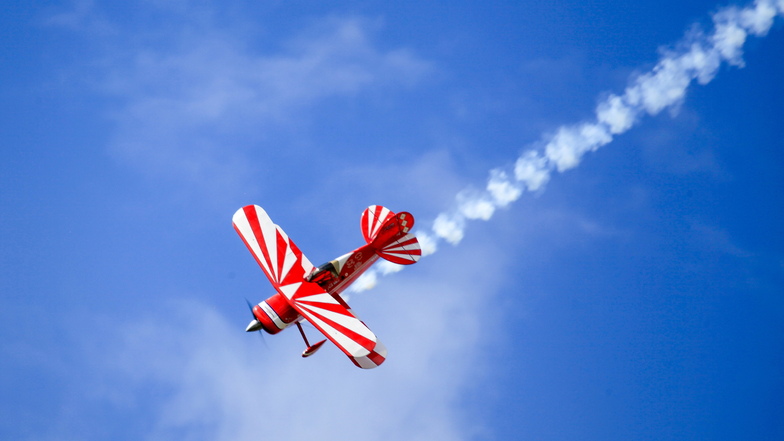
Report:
48,2,431,199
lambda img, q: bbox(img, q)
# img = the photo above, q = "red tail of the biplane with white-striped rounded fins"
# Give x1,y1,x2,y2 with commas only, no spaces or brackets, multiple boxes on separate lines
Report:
360,205,422,265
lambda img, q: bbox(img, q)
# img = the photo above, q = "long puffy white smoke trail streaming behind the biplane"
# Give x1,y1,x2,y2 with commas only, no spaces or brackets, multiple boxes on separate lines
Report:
353,0,784,292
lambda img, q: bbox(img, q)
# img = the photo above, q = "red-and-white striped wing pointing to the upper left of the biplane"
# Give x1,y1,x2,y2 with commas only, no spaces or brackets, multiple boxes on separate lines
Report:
232,205,313,289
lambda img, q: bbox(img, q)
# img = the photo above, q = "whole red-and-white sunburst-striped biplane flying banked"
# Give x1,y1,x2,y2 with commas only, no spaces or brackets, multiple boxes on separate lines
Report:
232,205,422,369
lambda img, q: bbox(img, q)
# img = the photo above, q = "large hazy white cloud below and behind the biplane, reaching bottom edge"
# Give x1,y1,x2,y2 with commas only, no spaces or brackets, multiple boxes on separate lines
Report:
81,232,502,441
